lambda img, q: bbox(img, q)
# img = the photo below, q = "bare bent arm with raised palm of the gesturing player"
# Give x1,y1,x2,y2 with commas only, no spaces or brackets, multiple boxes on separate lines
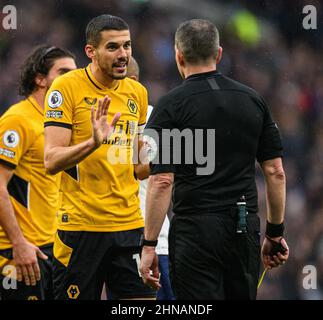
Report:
44,96,120,174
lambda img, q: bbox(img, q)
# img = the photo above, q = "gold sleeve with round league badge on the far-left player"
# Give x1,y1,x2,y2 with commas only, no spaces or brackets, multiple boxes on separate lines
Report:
0,115,35,169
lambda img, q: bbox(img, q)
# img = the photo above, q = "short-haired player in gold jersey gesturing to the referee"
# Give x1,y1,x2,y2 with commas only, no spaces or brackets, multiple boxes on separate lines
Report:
45,15,155,299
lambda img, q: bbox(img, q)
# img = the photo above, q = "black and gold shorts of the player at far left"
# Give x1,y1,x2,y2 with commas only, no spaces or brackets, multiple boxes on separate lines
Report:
0,244,54,300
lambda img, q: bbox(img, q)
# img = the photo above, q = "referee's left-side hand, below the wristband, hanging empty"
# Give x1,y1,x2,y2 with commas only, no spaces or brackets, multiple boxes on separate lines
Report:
139,246,161,290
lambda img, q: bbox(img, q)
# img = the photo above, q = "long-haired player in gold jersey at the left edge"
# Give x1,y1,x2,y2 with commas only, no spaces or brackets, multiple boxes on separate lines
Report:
0,46,76,300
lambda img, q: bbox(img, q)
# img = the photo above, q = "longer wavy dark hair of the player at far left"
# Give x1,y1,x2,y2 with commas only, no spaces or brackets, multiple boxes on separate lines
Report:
19,45,75,97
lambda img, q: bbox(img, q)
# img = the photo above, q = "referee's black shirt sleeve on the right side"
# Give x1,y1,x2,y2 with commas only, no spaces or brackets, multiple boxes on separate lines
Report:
257,99,283,162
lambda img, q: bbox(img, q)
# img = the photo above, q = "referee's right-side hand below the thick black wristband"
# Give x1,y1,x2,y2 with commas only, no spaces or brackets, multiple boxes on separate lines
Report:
261,237,289,269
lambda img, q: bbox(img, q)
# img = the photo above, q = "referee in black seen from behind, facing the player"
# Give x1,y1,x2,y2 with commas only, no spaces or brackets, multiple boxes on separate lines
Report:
140,19,289,300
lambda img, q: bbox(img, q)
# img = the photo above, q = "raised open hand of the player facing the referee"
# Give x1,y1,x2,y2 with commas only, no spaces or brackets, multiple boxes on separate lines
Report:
91,96,121,146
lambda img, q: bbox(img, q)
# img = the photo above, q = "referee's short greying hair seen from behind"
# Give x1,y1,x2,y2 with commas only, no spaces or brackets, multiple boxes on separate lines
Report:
175,19,219,64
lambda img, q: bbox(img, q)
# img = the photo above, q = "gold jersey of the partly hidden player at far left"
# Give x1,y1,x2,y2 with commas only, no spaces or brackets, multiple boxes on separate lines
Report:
0,97,60,249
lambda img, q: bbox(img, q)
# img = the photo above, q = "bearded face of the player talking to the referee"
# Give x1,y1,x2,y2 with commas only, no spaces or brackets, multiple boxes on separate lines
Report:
95,30,131,79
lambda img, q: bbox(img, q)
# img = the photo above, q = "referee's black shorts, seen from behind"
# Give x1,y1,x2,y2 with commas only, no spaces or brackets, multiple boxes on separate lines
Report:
169,212,260,300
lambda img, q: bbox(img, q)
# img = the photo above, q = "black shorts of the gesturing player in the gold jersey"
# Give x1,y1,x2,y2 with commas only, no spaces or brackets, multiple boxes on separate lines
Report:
54,228,156,300
